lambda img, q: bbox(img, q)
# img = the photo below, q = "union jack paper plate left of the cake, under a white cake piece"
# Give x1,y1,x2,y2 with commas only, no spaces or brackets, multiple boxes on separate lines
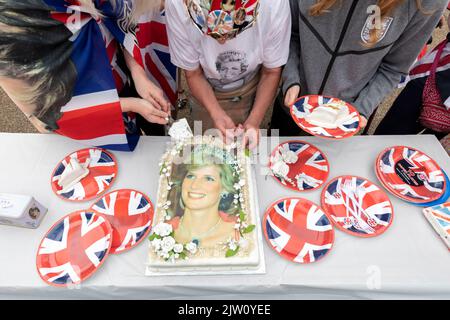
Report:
51,148,117,201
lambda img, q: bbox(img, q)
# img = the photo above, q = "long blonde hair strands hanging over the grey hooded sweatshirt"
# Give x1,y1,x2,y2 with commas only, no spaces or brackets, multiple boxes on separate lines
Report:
309,0,425,46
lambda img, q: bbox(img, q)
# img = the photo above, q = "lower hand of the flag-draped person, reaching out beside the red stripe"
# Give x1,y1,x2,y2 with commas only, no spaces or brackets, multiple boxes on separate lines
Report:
120,98,169,125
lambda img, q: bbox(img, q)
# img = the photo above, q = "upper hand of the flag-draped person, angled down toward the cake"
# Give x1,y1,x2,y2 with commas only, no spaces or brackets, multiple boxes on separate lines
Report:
133,69,170,115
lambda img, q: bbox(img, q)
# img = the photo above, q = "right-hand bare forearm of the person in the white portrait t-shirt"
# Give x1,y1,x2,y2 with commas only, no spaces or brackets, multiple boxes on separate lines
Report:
247,67,281,127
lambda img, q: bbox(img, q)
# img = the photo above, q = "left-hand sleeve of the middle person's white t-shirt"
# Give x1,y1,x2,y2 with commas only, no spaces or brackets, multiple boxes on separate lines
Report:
166,0,200,70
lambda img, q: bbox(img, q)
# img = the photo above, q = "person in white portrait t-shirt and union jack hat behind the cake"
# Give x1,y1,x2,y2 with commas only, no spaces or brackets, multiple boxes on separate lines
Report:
166,0,291,148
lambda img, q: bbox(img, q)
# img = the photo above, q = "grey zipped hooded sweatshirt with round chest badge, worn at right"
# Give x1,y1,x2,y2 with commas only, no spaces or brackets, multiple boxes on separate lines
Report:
283,0,448,117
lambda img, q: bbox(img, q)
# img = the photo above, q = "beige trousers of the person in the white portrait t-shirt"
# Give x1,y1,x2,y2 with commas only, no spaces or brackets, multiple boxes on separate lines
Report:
190,74,261,132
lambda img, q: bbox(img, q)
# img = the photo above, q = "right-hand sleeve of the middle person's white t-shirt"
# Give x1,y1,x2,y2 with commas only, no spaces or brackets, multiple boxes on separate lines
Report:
263,0,291,68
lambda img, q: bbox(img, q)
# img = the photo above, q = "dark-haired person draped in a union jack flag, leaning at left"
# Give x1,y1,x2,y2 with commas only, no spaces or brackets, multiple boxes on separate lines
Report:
0,0,170,151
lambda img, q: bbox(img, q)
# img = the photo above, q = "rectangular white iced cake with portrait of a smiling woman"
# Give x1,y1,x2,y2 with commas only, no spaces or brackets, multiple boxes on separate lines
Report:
146,136,265,275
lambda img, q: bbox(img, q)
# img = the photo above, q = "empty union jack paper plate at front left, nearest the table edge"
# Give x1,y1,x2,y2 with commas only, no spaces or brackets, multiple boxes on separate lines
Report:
36,211,112,287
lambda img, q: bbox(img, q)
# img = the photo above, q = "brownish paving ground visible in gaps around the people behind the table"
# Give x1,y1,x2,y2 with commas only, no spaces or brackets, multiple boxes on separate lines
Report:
0,19,448,138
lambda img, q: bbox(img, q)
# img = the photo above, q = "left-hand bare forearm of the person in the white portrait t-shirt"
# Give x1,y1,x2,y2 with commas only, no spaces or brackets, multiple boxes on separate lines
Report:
185,68,224,115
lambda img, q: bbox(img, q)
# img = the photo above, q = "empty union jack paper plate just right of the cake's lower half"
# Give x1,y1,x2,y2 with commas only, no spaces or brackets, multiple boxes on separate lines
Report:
263,198,334,264
